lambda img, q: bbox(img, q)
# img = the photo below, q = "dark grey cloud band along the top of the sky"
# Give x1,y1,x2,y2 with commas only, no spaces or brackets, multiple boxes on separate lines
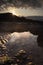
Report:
0,0,42,8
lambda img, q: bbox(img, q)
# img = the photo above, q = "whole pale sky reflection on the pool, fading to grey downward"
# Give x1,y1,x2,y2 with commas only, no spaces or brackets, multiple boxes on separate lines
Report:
5,32,38,60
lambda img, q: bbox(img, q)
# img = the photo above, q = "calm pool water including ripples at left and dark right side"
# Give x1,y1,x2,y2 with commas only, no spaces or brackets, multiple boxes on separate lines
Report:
0,32,43,65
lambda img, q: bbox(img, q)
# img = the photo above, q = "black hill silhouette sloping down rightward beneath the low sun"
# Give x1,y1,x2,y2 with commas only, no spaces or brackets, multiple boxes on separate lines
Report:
0,13,26,22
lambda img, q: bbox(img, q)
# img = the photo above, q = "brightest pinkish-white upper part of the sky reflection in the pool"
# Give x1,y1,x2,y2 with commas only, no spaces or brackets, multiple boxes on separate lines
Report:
10,32,37,42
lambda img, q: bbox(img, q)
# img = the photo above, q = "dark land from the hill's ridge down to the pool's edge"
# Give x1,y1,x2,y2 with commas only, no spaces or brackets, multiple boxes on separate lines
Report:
0,13,43,46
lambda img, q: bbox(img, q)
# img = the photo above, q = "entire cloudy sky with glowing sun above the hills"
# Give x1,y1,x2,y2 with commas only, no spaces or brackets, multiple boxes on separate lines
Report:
0,0,43,16
